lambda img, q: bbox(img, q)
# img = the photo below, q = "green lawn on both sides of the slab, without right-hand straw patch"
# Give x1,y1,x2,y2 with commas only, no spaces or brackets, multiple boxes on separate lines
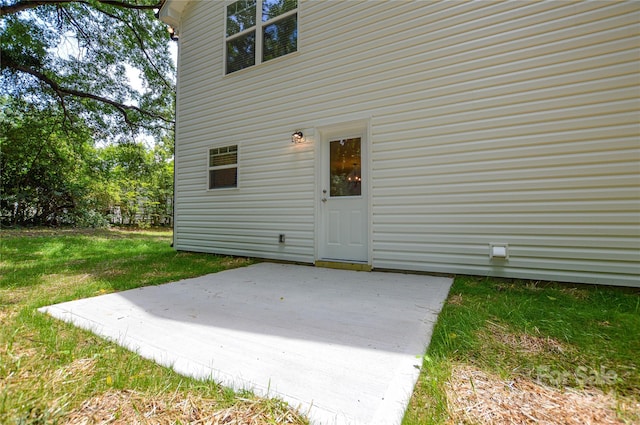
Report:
0,230,640,425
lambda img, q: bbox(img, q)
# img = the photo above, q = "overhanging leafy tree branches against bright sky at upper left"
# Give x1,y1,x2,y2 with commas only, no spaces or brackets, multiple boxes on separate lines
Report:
0,0,175,141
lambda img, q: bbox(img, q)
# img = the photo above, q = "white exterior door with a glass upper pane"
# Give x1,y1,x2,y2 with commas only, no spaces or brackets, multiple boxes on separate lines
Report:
319,134,369,263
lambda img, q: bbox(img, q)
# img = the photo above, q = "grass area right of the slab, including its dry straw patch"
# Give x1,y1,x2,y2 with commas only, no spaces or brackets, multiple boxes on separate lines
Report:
404,276,640,424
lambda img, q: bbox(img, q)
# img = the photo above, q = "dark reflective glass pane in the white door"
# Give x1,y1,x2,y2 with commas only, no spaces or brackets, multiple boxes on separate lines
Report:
329,137,362,196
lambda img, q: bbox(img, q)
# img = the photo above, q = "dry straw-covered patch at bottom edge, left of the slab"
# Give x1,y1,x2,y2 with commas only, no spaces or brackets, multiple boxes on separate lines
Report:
63,390,307,425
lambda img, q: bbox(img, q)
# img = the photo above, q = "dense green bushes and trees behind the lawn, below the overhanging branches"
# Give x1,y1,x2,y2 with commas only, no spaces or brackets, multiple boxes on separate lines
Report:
0,97,173,227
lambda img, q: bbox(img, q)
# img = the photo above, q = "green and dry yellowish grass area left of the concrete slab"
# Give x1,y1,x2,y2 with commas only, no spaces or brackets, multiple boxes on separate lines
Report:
0,230,306,425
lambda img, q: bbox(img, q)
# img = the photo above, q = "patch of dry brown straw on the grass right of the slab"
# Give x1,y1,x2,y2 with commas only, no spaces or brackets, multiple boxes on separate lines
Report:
446,365,628,425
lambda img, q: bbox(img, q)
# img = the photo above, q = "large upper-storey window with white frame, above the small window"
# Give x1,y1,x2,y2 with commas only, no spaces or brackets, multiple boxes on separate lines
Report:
225,0,298,74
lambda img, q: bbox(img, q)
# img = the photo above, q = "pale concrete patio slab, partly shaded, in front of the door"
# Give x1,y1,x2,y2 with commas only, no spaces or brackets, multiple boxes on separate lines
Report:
40,263,452,425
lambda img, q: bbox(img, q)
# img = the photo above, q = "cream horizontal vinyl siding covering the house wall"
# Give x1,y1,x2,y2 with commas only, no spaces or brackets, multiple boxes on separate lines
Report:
175,1,640,286
